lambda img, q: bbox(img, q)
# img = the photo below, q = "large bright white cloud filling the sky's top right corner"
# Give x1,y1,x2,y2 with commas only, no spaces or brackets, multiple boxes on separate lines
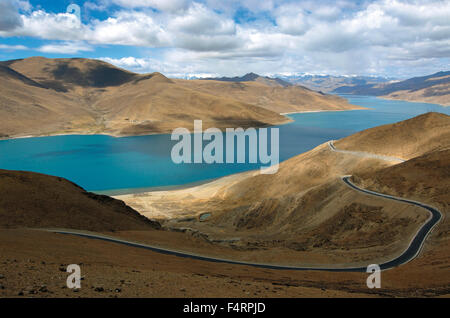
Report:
303,0,450,57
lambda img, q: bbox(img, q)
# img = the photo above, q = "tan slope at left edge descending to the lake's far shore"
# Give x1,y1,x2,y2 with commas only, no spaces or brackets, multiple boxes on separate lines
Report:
0,62,96,137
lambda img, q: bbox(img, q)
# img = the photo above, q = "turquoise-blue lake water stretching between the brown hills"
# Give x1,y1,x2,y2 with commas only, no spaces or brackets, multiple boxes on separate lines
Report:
0,95,450,194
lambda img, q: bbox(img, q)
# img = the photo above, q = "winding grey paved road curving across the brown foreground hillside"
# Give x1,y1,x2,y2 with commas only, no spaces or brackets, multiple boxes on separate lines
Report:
43,141,442,272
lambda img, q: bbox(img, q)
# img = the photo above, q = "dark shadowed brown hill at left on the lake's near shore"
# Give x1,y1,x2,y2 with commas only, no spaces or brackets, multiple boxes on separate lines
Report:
0,170,159,232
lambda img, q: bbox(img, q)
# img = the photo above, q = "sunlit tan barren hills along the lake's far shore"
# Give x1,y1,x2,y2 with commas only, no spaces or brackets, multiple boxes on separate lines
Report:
0,57,358,137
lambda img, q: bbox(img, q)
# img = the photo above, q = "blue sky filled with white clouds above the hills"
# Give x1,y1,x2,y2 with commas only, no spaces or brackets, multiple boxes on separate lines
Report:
0,0,450,78
